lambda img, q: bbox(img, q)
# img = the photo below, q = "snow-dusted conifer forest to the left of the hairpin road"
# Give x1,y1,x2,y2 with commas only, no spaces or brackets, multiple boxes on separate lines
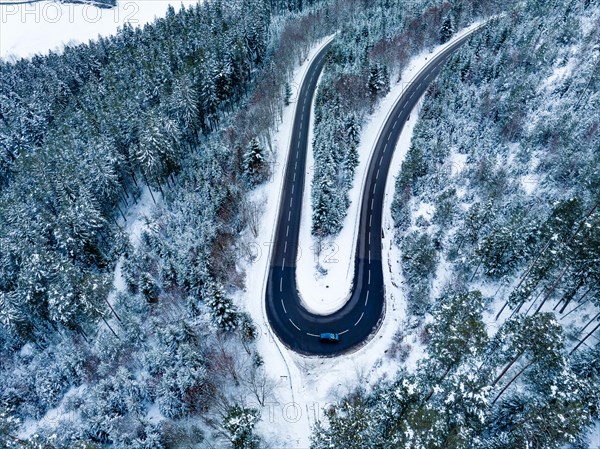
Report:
0,0,327,448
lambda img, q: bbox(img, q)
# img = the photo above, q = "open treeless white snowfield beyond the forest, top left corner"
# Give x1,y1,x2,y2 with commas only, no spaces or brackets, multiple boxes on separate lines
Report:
0,0,198,60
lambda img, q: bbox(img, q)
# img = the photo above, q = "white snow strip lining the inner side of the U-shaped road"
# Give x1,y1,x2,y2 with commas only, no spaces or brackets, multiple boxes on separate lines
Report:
296,22,488,315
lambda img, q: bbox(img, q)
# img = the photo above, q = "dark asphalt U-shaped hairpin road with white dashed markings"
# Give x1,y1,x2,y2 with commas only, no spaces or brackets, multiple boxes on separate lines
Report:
265,29,480,356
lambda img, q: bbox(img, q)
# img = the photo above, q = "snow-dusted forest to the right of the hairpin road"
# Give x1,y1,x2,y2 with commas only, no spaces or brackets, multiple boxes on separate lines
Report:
313,0,600,449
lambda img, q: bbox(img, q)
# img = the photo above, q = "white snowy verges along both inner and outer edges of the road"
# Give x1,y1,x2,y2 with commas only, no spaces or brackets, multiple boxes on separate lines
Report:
237,25,486,449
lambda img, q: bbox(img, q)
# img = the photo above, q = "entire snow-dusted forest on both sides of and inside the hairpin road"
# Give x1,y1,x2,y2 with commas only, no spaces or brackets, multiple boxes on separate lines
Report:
0,0,600,449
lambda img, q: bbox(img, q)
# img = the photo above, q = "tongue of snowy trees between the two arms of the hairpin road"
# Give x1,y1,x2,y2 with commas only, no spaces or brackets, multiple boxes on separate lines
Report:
311,0,503,237
